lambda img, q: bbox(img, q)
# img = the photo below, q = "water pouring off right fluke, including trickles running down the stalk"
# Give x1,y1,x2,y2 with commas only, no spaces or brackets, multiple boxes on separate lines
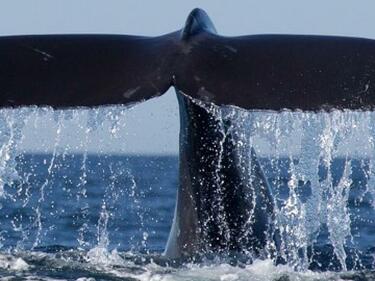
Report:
187,98,375,271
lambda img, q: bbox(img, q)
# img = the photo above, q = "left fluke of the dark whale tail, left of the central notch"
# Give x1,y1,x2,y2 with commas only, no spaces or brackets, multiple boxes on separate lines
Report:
0,35,176,107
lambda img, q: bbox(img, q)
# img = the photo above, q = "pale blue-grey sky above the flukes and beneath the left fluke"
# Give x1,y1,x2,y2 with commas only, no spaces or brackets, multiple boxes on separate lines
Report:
0,0,375,154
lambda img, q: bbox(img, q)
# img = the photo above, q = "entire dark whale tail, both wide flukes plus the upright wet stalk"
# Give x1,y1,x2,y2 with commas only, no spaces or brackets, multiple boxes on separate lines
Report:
0,9,375,257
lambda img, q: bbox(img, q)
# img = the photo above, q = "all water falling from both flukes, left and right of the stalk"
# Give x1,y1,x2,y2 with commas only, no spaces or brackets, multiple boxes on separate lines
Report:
0,103,375,278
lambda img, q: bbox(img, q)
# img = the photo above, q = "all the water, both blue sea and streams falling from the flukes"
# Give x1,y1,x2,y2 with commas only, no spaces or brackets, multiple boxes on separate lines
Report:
0,105,375,280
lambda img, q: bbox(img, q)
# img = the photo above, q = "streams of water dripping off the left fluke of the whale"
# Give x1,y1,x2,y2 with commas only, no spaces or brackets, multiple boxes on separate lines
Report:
0,107,143,249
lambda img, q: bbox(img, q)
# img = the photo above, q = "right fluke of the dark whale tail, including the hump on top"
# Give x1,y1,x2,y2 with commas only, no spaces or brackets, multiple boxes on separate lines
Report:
175,12,375,111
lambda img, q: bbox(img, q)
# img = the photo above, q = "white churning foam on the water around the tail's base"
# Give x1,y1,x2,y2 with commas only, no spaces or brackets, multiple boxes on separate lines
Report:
0,250,373,281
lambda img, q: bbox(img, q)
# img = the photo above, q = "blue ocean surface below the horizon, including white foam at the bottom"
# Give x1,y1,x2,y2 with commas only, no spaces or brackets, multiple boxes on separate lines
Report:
0,153,375,281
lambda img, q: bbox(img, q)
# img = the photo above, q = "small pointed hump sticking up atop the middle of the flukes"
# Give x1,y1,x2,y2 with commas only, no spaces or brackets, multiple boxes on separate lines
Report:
182,8,217,40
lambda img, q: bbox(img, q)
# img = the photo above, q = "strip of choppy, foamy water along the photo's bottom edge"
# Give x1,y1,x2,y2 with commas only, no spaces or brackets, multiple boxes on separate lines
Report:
0,247,375,281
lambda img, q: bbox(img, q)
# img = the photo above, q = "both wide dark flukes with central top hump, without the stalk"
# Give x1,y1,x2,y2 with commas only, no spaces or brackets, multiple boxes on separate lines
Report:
0,9,375,111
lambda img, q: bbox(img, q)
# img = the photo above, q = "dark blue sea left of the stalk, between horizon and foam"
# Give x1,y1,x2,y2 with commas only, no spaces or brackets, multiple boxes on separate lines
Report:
0,155,178,252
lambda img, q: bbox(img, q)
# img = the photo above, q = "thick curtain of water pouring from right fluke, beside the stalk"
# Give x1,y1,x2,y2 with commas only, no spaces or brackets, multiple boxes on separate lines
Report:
217,106,374,270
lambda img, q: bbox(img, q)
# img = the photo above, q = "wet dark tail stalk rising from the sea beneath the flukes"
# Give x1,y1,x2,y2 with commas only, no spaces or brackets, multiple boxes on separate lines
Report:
166,93,273,258
